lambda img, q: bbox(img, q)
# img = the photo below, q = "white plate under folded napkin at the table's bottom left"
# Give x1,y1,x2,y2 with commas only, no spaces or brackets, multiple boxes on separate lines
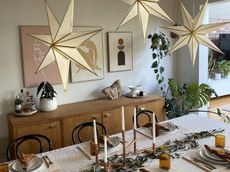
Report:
10,156,43,172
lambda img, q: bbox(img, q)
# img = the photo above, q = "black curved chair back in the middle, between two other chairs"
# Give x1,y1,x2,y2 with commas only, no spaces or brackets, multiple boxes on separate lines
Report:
72,122,106,144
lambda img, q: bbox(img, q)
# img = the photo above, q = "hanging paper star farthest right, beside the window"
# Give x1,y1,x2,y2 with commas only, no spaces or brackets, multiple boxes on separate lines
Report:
163,0,230,65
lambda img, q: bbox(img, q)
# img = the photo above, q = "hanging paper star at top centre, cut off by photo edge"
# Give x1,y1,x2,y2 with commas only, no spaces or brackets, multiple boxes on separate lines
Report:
116,0,174,40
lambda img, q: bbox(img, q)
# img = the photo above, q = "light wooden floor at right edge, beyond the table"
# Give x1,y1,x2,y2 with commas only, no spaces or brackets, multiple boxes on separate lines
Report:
208,95,230,120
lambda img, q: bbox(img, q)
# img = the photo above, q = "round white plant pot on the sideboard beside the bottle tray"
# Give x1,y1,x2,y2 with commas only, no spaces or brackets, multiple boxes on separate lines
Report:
39,97,57,112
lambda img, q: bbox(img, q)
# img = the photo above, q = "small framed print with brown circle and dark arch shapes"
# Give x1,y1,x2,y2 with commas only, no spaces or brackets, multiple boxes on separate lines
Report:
108,32,133,72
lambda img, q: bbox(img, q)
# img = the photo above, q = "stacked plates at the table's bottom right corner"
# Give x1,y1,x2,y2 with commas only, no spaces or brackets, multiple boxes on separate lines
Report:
199,147,229,165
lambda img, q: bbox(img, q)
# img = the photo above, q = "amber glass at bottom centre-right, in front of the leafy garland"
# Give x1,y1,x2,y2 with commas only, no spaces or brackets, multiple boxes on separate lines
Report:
159,145,170,170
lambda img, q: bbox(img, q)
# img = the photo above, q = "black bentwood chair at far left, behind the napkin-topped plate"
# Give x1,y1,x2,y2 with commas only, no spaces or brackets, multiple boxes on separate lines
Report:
7,134,52,161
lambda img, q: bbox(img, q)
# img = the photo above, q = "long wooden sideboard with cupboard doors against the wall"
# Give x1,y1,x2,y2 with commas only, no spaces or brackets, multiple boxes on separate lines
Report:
7,95,164,152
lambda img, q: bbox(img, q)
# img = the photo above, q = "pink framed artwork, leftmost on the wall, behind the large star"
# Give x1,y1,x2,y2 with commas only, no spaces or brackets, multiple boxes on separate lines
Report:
20,26,61,87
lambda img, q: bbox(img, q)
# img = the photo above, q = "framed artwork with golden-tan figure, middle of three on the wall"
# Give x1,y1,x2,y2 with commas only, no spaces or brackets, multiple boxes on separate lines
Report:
70,26,104,82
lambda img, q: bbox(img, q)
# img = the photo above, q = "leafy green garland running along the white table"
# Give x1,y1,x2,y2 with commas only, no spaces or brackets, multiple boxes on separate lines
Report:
82,129,224,172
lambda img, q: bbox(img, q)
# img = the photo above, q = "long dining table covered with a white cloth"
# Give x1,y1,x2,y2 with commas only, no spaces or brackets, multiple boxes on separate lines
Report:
6,113,230,172
